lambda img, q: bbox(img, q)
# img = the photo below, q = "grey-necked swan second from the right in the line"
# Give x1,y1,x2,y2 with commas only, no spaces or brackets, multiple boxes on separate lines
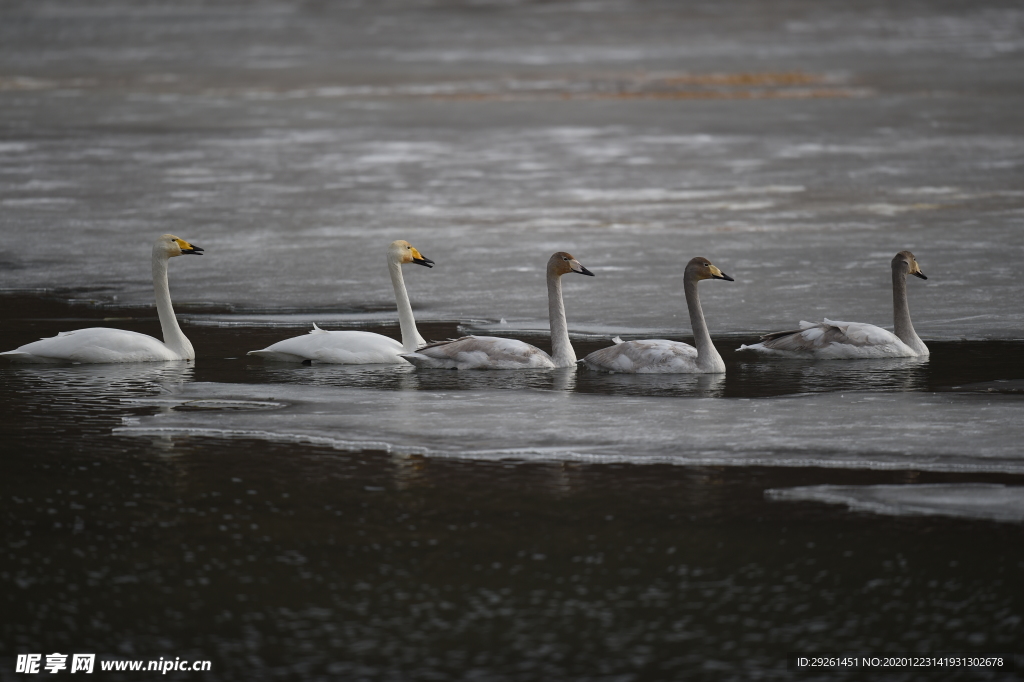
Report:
583,258,734,374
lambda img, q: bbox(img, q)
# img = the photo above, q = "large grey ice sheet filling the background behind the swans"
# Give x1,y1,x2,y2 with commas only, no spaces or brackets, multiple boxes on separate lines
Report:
0,1,1024,340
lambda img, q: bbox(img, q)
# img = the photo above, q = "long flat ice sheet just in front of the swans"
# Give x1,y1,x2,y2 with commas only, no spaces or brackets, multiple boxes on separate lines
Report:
118,382,1024,473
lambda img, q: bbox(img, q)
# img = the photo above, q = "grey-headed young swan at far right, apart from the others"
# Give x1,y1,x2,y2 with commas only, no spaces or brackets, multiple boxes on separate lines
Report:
738,251,928,359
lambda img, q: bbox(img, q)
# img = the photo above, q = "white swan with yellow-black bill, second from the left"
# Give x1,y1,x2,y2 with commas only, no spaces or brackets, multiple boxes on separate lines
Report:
249,240,434,365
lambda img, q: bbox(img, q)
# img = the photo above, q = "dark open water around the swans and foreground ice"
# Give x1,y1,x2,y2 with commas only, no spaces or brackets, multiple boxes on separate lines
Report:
0,297,1024,680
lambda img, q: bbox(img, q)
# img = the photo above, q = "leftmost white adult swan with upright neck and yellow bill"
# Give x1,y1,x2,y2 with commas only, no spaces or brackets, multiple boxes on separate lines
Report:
0,235,203,363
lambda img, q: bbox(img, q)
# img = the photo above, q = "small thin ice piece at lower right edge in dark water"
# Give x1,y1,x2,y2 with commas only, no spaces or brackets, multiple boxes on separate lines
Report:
765,483,1024,522
